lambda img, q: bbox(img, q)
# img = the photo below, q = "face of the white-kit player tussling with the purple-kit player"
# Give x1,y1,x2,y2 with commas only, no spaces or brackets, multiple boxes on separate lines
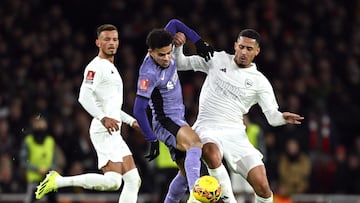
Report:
234,36,260,68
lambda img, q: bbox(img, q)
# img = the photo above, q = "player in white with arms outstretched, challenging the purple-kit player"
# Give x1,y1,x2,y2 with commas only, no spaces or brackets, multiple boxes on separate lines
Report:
174,29,304,203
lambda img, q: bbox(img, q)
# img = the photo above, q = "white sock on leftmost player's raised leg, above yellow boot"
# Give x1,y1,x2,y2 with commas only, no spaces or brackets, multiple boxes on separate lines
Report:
55,172,121,191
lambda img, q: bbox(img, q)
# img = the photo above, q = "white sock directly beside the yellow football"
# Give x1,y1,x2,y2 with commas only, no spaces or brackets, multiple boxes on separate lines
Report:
208,164,237,203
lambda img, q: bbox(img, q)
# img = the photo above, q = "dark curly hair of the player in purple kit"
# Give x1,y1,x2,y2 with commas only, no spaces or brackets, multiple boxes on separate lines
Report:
146,29,173,49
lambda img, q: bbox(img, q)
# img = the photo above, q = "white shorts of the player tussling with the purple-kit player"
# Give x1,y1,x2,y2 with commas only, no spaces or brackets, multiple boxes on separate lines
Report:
195,126,264,178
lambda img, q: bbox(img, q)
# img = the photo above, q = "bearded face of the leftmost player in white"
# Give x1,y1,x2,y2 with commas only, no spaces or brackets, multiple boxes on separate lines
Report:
96,30,119,57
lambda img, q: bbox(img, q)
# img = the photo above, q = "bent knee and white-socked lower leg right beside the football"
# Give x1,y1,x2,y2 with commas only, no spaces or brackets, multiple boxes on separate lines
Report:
203,142,236,203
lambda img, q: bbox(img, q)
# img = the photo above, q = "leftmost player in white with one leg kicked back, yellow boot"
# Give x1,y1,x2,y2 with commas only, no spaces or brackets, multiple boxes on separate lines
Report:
36,24,141,203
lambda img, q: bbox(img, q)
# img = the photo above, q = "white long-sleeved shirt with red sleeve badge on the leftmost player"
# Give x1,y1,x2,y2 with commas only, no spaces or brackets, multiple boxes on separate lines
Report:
79,56,135,131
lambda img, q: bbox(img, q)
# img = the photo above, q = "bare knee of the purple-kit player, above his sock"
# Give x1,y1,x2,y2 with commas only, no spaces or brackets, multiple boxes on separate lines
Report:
176,125,202,151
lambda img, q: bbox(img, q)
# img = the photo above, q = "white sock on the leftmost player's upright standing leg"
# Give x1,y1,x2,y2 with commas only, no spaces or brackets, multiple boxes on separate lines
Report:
119,168,141,203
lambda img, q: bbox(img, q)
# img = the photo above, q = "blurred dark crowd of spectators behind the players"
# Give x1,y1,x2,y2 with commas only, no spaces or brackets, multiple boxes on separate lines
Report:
0,0,360,200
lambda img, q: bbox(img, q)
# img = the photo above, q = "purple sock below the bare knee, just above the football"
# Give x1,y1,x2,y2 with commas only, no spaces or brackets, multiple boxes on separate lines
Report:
184,147,201,190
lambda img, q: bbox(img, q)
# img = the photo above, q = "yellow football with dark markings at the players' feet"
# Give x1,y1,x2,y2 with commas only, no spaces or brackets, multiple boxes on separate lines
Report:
193,175,222,203
